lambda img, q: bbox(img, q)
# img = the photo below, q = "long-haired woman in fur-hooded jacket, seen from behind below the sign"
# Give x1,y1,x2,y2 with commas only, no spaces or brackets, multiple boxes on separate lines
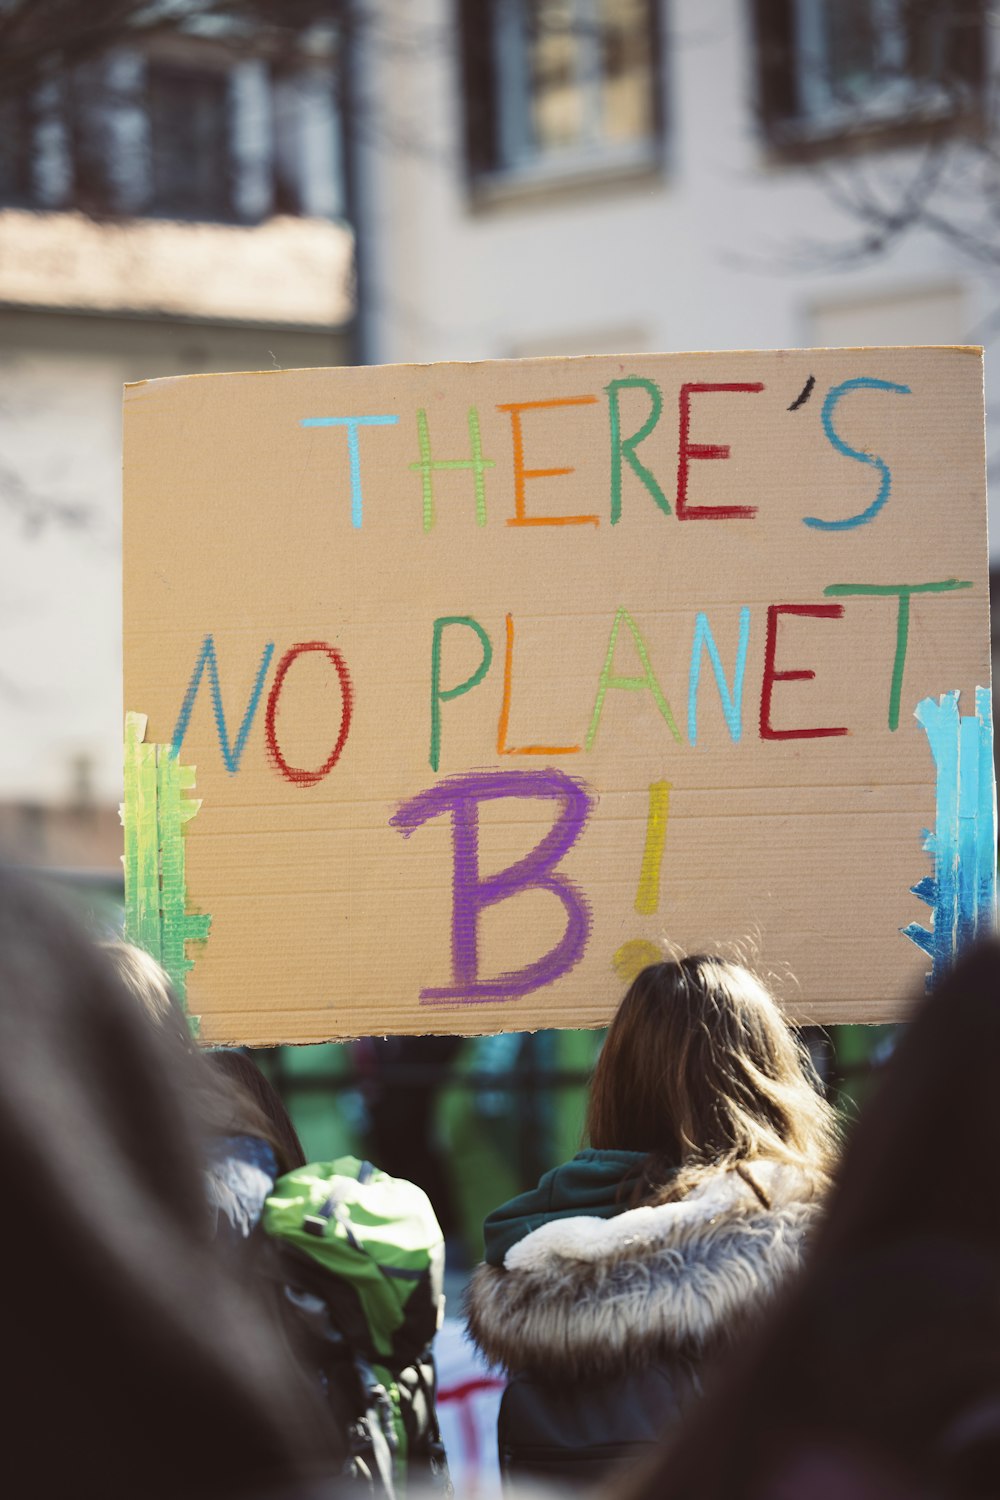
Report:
468,957,837,1484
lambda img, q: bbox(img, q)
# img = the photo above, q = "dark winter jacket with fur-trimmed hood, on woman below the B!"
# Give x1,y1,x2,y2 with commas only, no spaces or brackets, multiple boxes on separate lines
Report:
466,1151,822,1494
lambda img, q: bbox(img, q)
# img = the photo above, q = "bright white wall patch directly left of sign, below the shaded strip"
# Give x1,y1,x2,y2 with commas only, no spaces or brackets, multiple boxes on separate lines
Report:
0,347,121,801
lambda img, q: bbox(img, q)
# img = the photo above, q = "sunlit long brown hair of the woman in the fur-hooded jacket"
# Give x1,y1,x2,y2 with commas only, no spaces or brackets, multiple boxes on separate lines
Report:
586,954,838,1202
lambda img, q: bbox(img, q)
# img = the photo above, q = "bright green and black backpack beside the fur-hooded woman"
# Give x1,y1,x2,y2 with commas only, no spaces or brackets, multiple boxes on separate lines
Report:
262,1157,450,1496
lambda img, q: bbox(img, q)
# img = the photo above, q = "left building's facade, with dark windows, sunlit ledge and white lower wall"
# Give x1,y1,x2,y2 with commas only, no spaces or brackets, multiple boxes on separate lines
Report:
0,20,352,846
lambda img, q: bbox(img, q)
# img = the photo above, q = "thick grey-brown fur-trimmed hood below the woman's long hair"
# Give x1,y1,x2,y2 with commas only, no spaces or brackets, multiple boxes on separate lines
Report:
466,1163,820,1379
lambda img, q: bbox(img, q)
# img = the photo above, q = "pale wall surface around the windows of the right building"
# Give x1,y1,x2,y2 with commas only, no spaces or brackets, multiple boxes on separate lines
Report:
364,0,1000,558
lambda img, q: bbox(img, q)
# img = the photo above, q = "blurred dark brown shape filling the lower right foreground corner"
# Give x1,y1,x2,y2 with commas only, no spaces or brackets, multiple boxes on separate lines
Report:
626,941,1000,1500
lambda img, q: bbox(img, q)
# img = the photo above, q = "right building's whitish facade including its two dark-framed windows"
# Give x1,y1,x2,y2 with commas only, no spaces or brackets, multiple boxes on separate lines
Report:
358,0,1000,516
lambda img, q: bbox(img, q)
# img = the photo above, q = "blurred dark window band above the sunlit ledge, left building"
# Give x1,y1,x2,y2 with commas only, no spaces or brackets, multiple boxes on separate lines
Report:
0,47,343,224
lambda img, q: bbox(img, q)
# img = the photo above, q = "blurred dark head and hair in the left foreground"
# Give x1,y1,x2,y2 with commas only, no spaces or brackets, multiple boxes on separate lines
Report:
0,872,338,1500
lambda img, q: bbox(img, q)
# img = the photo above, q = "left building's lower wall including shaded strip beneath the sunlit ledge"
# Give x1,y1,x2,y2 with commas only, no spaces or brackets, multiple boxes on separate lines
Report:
0,312,346,803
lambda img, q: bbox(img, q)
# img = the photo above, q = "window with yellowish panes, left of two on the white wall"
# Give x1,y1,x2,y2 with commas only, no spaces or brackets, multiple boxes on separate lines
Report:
462,0,660,180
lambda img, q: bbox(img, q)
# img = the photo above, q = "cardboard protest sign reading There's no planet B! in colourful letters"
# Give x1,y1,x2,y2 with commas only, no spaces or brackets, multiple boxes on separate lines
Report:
124,348,996,1044
